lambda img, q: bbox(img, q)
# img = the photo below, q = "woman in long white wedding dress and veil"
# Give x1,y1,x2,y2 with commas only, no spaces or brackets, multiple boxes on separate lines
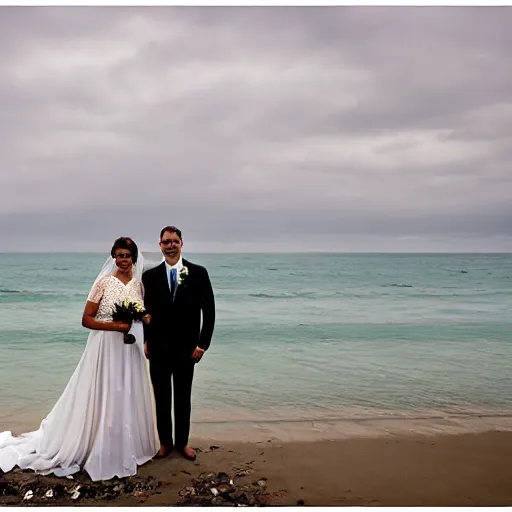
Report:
0,237,158,481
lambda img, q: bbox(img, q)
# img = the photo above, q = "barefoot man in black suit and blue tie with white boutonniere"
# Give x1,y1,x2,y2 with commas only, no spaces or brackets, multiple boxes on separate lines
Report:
142,226,215,460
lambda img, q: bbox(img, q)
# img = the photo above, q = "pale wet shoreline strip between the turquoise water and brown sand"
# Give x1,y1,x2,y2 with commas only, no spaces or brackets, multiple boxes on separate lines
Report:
0,410,512,443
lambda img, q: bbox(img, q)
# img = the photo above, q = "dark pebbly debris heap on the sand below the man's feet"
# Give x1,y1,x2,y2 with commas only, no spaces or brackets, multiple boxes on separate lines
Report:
177,471,272,507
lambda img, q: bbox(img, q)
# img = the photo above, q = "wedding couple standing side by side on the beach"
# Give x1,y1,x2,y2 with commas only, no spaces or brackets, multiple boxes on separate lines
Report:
0,226,215,481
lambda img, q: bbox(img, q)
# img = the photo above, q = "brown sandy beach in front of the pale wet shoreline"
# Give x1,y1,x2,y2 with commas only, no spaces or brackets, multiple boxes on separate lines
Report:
0,431,512,506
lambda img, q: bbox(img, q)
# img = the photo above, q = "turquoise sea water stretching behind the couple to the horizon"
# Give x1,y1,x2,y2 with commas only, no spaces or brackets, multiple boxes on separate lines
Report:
0,254,512,436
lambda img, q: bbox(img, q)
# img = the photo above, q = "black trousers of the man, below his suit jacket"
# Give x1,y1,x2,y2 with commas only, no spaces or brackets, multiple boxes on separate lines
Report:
149,356,195,448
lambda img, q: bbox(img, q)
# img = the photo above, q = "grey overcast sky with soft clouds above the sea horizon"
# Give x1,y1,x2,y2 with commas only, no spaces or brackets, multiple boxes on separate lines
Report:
0,6,512,252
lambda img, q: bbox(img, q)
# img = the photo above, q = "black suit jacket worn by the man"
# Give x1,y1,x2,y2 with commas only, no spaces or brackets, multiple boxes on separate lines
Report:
142,259,215,358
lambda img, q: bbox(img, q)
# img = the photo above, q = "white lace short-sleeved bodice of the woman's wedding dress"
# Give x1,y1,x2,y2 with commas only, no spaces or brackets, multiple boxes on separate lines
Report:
87,275,143,322
